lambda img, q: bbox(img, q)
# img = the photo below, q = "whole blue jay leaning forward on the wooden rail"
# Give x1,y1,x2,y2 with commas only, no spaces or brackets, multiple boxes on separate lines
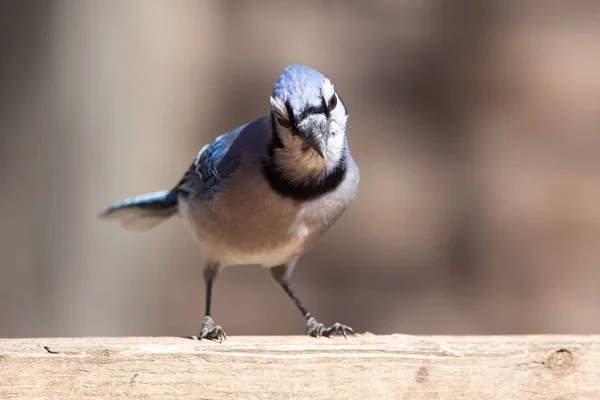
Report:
100,65,359,341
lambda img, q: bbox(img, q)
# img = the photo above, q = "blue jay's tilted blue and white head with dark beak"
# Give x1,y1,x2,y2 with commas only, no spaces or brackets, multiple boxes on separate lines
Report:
271,65,348,164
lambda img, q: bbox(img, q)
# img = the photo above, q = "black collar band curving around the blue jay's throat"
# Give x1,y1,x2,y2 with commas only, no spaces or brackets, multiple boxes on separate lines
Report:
262,142,346,201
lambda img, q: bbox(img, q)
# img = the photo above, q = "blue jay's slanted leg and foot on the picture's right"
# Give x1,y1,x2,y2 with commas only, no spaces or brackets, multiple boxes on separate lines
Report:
271,264,354,339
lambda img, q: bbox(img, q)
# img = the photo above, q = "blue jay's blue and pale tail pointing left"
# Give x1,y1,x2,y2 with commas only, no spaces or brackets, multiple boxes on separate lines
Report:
98,190,177,232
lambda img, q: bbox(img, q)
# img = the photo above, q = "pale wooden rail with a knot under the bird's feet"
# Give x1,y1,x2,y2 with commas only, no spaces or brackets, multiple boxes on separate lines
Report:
0,335,600,400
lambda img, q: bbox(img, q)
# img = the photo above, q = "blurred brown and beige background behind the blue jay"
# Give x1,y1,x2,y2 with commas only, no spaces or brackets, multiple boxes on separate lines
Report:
0,0,600,337
